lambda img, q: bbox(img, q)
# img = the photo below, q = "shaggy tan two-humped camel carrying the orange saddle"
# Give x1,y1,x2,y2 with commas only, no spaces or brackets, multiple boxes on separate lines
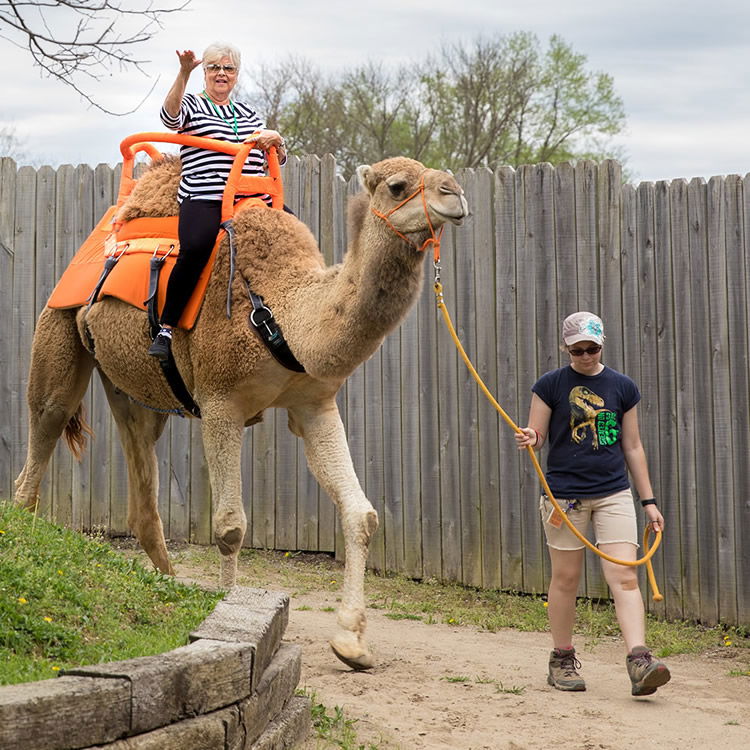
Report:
16,153,468,669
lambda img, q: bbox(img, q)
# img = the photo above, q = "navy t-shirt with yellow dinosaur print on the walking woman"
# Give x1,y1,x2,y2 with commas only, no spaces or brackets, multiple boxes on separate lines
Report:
531,365,641,500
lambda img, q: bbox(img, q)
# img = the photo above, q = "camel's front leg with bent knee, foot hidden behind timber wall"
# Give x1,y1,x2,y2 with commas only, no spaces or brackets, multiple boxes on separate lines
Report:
201,402,247,588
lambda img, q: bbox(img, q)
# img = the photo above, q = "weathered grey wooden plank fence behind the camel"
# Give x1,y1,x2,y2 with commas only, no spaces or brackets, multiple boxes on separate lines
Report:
0,156,750,624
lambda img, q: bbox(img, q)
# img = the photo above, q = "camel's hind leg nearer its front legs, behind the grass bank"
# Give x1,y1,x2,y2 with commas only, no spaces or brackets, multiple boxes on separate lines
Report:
99,371,174,575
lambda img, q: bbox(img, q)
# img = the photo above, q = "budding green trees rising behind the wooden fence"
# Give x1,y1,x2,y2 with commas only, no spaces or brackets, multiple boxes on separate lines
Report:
251,32,625,175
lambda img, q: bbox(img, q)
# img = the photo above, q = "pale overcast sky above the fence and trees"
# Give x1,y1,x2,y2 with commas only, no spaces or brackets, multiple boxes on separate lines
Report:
0,0,750,181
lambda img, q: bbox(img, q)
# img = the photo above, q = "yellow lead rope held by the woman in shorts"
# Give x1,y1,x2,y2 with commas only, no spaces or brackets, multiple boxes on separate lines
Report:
435,276,664,602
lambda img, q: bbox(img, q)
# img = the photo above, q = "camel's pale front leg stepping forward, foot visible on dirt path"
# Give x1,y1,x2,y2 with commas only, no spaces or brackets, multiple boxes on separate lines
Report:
289,400,378,669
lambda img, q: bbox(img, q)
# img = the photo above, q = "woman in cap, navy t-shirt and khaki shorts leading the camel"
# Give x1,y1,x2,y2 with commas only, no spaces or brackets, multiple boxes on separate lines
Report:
516,312,670,695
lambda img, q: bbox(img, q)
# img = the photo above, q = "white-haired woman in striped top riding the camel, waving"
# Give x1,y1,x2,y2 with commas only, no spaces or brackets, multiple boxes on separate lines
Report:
148,43,286,360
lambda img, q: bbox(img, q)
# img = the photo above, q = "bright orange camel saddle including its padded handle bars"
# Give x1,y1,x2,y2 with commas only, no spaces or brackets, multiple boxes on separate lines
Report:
47,133,284,330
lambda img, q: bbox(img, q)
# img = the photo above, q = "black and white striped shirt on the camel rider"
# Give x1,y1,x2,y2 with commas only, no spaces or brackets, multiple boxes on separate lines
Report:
161,94,268,203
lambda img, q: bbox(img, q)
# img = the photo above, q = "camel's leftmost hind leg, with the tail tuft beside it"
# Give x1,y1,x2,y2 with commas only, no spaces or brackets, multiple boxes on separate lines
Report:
15,307,94,510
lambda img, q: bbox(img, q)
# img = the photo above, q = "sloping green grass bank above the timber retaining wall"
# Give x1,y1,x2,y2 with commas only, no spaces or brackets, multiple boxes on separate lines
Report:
0,502,222,685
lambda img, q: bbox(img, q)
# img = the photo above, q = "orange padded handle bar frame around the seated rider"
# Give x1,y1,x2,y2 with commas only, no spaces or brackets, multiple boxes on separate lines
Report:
117,132,284,221
